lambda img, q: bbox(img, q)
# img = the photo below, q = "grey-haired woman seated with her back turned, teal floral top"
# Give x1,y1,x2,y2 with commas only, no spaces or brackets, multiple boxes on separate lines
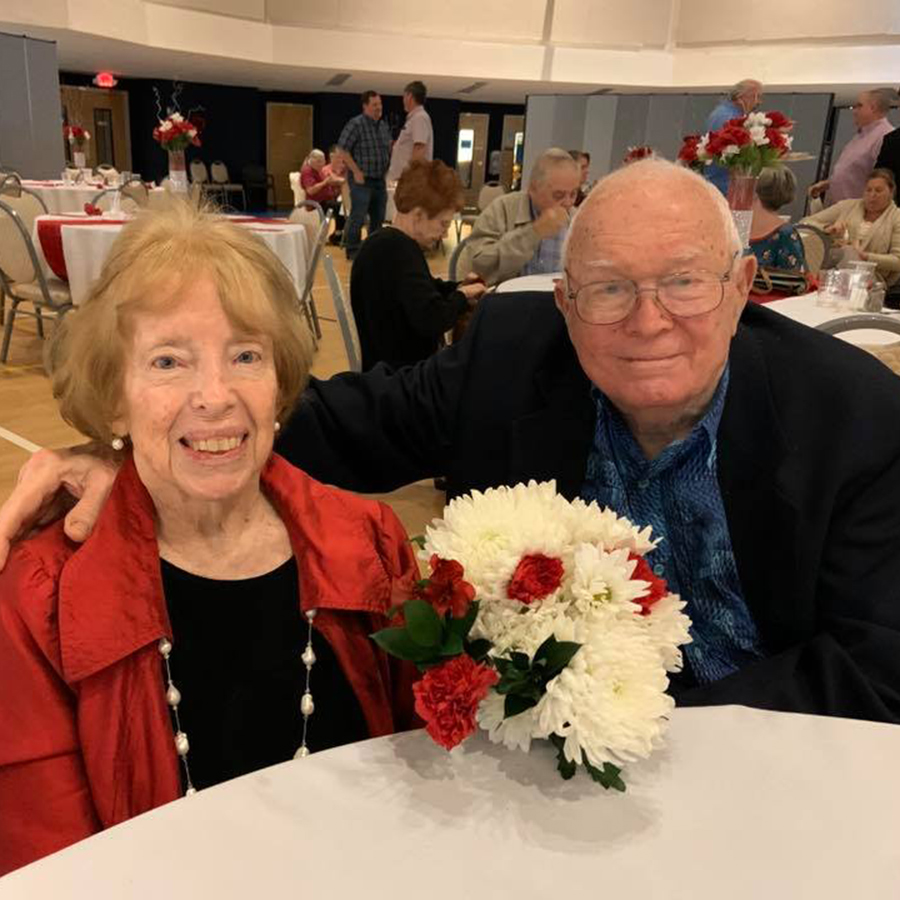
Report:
750,166,806,272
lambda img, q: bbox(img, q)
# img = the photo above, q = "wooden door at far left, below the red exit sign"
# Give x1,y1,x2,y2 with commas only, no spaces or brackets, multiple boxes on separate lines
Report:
59,85,131,172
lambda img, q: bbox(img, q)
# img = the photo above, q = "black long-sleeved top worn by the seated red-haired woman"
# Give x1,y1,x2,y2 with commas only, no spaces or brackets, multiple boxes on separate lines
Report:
350,228,467,371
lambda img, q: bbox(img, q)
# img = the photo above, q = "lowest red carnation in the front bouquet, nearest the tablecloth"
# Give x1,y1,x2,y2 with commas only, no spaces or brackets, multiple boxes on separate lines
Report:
413,653,499,750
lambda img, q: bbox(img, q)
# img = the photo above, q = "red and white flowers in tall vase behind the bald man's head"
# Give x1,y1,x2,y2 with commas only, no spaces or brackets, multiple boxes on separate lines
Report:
678,111,794,247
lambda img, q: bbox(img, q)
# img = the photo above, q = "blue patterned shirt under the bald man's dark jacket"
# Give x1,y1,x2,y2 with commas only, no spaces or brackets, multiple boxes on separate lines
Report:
581,366,762,684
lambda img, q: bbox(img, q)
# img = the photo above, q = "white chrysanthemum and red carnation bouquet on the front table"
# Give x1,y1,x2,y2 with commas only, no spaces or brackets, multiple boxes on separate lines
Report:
373,481,691,790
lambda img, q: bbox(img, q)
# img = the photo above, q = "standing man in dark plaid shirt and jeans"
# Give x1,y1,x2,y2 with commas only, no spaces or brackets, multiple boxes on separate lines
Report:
338,91,391,260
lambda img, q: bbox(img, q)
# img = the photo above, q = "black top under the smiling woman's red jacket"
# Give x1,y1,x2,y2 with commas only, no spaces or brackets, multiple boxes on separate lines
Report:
161,557,369,788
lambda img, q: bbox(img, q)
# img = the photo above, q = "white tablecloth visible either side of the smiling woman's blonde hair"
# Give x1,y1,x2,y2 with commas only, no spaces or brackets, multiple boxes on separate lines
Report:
34,216,309,306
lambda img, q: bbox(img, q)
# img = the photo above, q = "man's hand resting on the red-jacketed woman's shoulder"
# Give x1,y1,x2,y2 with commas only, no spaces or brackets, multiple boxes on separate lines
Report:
0,444,118,569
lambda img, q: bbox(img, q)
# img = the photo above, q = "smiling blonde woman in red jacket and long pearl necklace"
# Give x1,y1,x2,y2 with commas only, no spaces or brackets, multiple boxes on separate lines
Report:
0,204,416,874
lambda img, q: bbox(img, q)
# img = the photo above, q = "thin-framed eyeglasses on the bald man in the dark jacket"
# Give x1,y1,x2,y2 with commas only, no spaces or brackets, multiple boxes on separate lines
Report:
566,254,737,325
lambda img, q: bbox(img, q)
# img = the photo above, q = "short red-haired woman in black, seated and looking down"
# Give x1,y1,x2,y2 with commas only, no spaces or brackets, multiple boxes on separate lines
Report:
350,160,485,371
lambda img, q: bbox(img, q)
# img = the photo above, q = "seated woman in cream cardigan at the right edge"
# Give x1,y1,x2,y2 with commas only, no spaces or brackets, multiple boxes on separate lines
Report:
803,169,900,286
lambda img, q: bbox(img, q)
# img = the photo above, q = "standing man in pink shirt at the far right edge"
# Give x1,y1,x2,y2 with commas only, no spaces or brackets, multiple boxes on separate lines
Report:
809,88,894,206
